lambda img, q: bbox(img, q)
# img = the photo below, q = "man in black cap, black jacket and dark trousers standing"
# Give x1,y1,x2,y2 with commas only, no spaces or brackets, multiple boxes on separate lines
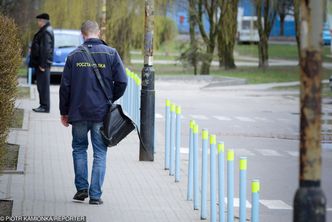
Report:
29,13,54,113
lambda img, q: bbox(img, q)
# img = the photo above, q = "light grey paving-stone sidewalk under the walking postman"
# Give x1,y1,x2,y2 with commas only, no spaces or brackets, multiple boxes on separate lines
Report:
0,86,199,222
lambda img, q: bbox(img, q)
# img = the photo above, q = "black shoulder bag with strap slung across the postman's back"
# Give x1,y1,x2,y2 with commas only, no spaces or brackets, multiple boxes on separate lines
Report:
80,45,136,147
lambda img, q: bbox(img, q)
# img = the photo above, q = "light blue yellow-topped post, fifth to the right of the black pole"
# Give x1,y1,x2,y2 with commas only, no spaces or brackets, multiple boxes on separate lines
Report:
193,124,199,210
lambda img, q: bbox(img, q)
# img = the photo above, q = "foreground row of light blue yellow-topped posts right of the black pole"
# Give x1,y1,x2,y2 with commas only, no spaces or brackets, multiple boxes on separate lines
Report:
165,99,260,222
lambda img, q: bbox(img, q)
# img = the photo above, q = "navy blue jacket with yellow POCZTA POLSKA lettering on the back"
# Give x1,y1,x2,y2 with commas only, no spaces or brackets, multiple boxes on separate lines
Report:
60,39,127,123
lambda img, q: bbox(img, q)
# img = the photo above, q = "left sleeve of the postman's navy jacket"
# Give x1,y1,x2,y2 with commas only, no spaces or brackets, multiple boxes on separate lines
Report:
59,57,72,115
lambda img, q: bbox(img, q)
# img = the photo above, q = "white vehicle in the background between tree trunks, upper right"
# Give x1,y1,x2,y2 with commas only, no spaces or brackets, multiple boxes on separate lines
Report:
237,16,259,43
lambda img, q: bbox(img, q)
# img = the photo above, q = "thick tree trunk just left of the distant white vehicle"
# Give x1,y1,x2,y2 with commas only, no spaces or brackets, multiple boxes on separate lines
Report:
218,0,238,69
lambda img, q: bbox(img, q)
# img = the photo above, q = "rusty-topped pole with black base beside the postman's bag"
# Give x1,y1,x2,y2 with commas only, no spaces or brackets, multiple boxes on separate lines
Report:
139,0,155,161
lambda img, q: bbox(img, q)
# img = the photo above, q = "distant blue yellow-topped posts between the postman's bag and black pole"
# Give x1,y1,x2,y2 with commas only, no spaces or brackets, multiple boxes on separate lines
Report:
120,69,141,127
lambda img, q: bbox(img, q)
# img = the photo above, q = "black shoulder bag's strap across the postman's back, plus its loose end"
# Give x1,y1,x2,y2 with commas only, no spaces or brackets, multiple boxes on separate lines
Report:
79,45,152,158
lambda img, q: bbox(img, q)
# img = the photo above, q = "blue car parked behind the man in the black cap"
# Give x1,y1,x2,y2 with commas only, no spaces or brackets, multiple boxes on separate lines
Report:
27,29,83,82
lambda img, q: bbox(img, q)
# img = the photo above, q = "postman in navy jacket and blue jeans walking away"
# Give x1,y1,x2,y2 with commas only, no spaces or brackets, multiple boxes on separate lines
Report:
60,21,127,204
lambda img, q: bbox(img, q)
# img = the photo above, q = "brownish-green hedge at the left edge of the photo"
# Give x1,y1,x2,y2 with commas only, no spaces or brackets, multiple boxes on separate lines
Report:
0,15,21,166
